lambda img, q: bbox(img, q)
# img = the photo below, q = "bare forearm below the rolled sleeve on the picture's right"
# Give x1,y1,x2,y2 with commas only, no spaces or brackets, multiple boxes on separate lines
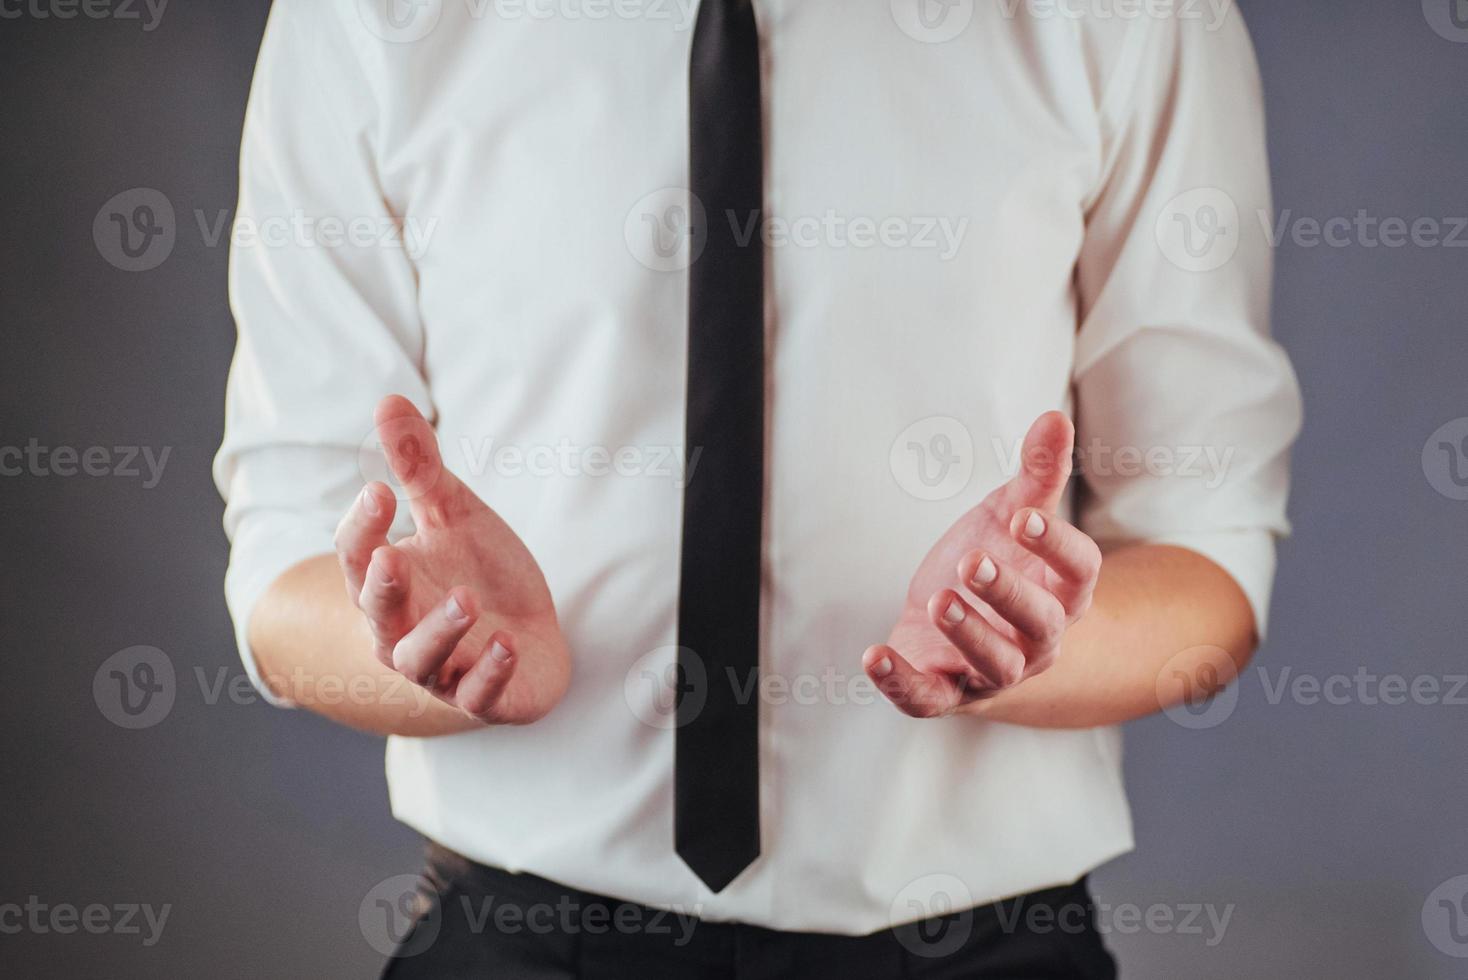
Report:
978,544,1255,728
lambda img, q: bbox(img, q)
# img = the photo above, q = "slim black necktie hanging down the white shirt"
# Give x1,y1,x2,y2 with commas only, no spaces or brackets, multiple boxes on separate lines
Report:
674,0,765,892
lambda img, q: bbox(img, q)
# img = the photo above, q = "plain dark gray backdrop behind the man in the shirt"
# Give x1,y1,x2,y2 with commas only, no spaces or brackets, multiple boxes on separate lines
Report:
0,0,1468,980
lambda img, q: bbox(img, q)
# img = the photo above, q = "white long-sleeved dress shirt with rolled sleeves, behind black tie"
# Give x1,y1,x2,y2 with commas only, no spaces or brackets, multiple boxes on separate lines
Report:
216,0,1299,933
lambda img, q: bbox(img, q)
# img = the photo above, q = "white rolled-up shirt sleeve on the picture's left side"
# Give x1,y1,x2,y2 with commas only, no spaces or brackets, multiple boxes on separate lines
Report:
214,0,430,703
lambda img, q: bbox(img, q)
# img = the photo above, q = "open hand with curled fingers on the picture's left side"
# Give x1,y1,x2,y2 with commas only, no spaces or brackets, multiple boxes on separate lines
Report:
336,395,571,725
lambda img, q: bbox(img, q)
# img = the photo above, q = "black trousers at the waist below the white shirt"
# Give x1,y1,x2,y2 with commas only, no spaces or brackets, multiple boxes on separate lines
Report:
383,846,1116,980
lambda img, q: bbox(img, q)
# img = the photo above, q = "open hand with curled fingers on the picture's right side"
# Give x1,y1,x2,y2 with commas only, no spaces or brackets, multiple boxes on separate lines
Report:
862,412,1101,717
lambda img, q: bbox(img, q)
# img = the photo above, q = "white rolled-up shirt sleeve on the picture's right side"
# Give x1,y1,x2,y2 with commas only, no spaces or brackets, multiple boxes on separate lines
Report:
1075,9,1301,637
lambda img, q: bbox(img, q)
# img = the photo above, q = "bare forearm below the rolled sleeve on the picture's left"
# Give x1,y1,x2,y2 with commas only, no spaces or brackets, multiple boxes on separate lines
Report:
250,555,480,736
